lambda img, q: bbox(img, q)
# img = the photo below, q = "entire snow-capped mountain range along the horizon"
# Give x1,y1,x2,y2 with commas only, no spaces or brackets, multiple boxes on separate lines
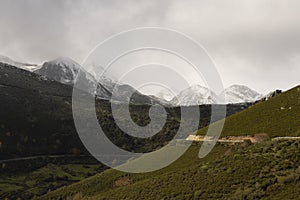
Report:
0,56,271,106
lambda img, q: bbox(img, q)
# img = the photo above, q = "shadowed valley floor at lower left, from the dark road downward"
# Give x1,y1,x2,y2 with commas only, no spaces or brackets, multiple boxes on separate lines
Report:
0,157,105,199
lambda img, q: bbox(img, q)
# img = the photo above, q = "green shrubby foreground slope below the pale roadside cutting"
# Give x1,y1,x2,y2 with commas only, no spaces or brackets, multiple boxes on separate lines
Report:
40,141,300,200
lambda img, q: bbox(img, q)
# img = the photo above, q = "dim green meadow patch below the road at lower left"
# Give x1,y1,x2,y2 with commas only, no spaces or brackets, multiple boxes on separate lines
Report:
0,164,99,199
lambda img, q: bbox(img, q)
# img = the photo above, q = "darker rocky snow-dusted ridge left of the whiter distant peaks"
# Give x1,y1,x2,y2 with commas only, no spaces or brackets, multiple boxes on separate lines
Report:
33,58,156,104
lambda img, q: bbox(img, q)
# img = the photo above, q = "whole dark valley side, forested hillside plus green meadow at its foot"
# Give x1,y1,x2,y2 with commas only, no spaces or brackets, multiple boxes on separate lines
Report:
0,63,252,199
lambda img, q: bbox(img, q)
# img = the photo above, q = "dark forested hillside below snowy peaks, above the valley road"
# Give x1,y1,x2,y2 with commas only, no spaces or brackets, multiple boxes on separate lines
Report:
0,64,250,159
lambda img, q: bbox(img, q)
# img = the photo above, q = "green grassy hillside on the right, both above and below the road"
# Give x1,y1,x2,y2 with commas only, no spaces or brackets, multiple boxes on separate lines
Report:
41,87,300,199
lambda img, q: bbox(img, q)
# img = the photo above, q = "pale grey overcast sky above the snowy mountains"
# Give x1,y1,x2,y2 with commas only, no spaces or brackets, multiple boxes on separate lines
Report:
0,0,300,93
